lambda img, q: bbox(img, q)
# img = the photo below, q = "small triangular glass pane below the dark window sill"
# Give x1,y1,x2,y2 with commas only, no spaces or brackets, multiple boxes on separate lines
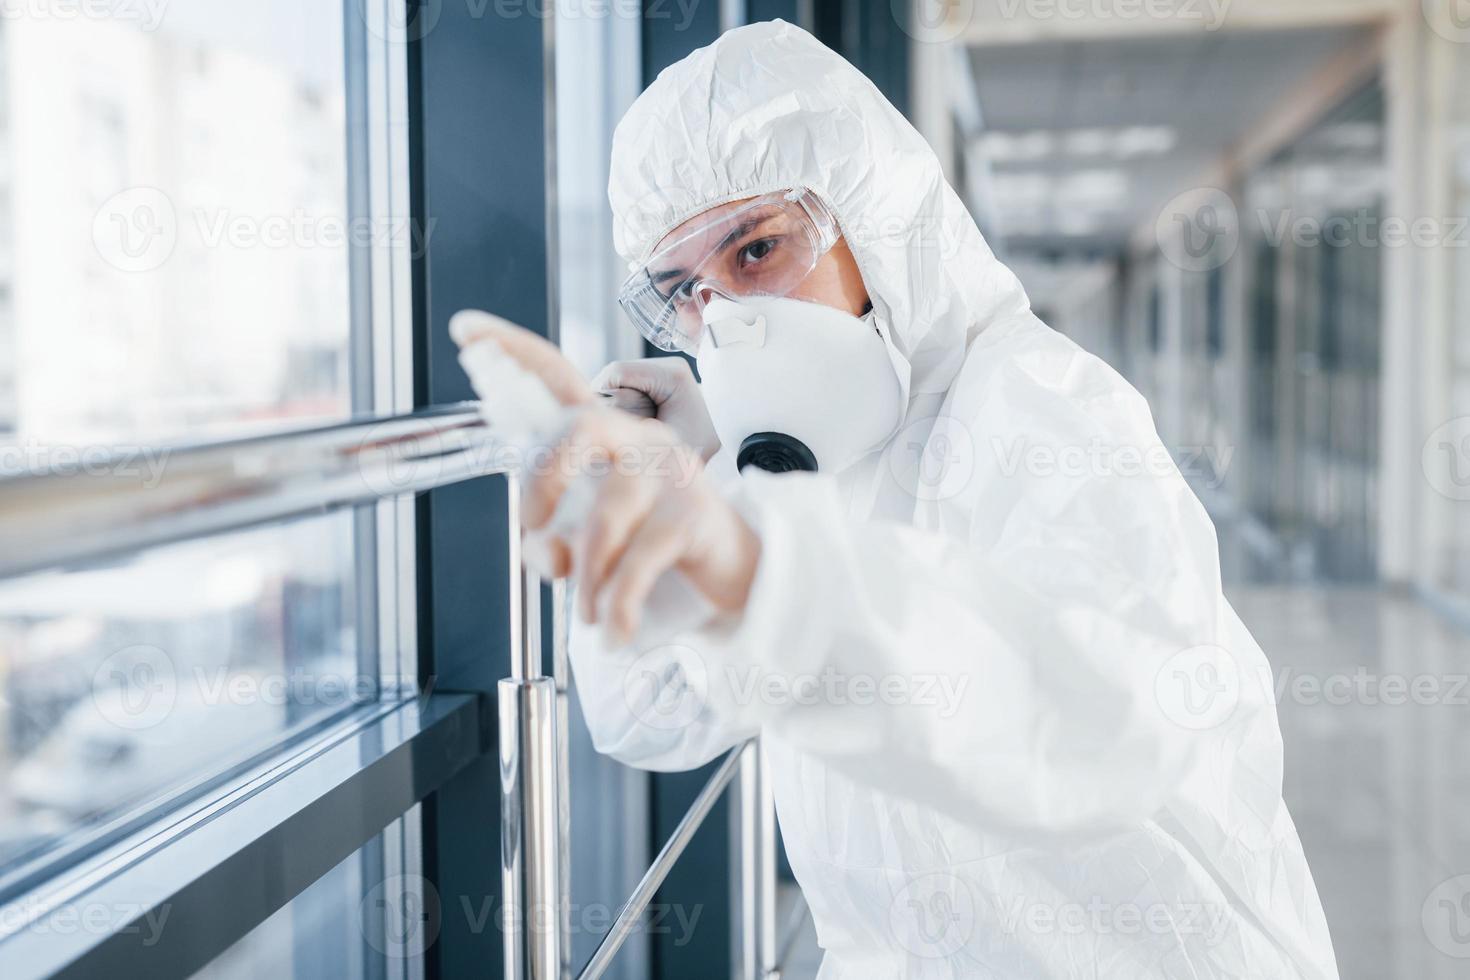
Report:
194,823,396,980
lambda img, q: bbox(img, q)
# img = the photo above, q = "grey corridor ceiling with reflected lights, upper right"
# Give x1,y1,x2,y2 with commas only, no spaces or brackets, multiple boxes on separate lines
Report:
969,26,1369,254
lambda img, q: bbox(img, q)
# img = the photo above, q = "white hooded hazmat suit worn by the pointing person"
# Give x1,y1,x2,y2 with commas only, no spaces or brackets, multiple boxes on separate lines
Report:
572,22,1336,980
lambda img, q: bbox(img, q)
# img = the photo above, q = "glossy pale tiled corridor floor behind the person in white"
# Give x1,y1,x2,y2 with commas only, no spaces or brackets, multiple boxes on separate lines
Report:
782,586,1470,980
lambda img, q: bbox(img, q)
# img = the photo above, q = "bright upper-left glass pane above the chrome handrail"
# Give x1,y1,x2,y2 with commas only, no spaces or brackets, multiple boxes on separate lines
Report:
0,0,352,443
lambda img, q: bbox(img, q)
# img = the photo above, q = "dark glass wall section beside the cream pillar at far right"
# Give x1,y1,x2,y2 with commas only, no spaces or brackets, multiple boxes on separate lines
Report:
1242,84,1397,582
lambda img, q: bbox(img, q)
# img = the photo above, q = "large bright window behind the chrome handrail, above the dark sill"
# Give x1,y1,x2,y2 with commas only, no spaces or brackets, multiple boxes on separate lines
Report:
0,0,423,976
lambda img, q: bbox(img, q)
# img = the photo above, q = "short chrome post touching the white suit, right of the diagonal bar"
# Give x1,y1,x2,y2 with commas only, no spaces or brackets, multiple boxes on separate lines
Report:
731,741,781,980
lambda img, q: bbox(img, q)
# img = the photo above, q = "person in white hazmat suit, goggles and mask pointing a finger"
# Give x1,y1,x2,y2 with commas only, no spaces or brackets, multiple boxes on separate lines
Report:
456,22,1336,980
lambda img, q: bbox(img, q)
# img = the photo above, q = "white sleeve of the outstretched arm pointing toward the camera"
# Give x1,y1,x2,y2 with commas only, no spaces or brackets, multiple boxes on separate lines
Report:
691,322,1258,832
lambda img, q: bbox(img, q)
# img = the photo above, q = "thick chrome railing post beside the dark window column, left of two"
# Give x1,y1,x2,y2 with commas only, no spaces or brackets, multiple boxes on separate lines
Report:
498,479,567,980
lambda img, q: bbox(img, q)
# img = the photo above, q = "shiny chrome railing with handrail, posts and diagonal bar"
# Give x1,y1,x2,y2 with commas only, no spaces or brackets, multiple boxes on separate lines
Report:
0,404,779,980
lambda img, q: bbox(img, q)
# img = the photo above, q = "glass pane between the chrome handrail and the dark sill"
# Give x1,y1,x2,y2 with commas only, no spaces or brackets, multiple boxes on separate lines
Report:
0,511,366,882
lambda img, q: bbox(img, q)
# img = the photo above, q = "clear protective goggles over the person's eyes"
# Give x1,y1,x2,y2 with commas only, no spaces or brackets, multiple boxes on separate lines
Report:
617,188,839,354
